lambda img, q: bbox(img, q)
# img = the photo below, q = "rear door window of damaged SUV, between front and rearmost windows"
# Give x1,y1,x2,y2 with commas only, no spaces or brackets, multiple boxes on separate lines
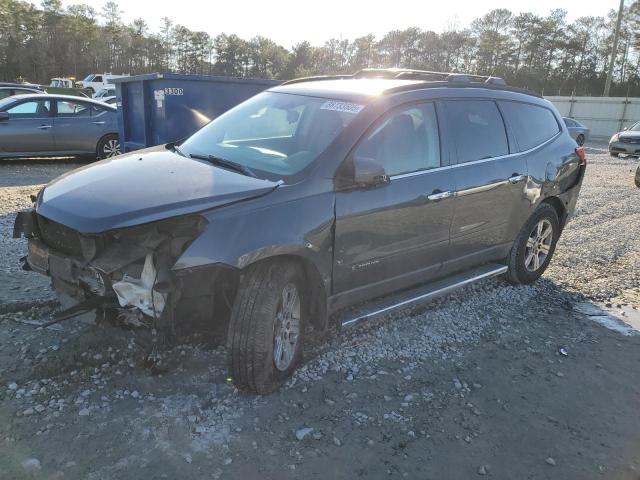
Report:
444,100,509,163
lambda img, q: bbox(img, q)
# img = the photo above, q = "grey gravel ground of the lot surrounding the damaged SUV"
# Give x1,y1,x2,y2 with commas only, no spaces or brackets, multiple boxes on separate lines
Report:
0,146,640,480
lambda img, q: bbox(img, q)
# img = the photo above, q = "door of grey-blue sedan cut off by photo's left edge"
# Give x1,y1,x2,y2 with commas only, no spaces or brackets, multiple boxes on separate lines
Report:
0,99,55,154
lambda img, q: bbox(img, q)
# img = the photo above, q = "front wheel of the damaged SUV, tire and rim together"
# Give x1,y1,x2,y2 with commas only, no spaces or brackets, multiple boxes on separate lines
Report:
227,261,308,394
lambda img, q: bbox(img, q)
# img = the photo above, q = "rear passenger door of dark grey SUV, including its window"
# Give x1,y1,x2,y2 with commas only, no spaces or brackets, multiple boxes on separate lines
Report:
441,99,529,270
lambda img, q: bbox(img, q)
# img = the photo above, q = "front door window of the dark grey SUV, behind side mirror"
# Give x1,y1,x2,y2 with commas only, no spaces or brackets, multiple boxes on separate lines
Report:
355,103,440,175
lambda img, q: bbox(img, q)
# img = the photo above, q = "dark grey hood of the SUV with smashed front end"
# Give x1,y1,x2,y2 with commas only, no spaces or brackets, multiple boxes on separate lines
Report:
36,147,278,233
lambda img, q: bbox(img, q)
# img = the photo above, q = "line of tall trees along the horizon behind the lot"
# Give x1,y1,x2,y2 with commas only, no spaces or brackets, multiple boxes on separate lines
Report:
0,0,640,96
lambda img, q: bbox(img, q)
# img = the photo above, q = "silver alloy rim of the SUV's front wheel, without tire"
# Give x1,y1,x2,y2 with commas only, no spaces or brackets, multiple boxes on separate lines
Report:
273,283,300,372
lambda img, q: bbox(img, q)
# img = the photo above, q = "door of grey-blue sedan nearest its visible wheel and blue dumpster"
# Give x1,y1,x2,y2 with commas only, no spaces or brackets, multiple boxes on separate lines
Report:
53,99,110,153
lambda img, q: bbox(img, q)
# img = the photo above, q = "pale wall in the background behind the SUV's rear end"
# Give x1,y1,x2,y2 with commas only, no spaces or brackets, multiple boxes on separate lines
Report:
545,97,640,140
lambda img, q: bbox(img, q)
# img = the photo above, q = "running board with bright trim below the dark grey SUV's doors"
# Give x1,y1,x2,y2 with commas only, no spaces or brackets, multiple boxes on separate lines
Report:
338,263,508,327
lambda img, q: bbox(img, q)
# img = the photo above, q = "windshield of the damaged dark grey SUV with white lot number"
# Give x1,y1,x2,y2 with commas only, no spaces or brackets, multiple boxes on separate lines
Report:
180,92,362,178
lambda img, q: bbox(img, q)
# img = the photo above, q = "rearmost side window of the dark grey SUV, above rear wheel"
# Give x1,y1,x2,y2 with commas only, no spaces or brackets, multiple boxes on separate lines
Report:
499,102,560,152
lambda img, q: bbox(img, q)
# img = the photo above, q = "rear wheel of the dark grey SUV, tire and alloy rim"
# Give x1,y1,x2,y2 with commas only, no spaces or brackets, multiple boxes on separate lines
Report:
506,203,560,284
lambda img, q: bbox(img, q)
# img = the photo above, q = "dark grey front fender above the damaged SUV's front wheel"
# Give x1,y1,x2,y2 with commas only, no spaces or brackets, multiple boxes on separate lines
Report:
173,192,334,291
